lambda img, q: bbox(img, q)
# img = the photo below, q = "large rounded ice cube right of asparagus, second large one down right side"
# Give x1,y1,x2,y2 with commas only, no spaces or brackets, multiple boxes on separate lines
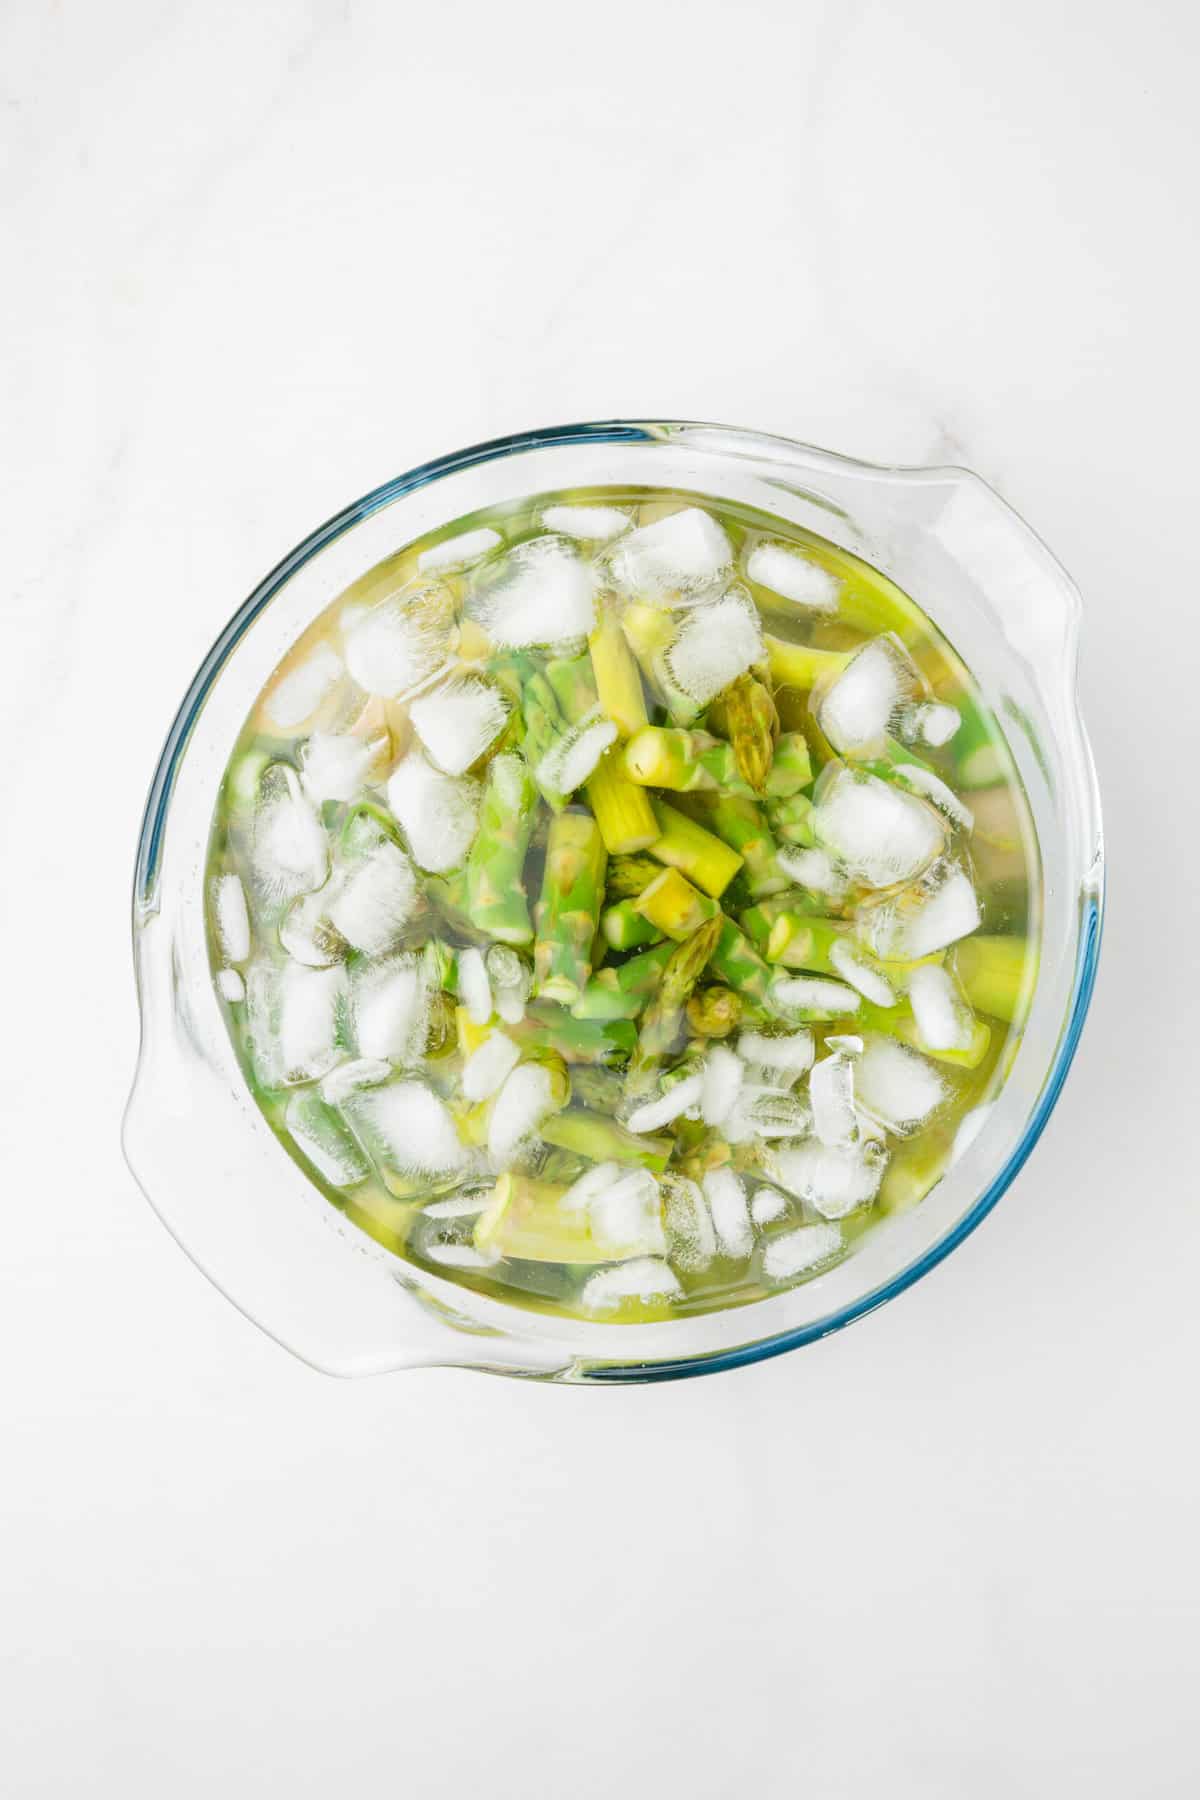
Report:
811,765,946,887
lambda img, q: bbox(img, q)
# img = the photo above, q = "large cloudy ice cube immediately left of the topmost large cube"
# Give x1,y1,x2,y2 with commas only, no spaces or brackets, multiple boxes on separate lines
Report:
468,536,596,650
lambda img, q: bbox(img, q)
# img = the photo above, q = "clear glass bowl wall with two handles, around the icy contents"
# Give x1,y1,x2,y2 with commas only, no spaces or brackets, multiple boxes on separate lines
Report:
124,421,1103,1382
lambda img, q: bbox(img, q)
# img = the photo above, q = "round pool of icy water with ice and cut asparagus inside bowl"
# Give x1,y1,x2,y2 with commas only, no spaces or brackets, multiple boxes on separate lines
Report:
207,490,1040,1323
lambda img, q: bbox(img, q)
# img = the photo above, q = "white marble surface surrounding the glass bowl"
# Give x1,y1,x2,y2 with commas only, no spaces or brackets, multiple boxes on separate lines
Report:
0,0,1200,1800
